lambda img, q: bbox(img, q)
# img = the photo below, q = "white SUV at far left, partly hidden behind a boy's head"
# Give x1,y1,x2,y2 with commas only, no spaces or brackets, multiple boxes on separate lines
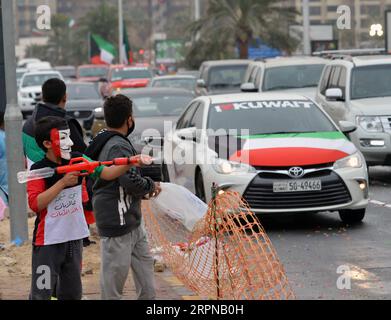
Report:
18,71,64,117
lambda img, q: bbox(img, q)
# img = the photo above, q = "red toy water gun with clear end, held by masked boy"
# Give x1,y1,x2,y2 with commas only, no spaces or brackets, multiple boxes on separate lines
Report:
18,155,153,183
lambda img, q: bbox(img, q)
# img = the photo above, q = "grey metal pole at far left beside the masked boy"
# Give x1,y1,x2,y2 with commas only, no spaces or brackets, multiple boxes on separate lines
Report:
1,0,28,244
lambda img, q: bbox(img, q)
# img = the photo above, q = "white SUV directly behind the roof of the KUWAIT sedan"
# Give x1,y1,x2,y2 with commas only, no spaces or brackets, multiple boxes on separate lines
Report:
241,56,327,98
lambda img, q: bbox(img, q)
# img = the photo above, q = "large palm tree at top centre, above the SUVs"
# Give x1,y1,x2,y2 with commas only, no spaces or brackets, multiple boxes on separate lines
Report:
189,0,297,59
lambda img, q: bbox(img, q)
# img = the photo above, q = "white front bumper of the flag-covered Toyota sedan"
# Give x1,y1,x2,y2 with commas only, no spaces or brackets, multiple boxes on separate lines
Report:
203,167,369,213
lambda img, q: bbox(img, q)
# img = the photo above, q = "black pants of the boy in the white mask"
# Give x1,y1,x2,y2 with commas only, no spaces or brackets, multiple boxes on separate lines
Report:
30,240,83,300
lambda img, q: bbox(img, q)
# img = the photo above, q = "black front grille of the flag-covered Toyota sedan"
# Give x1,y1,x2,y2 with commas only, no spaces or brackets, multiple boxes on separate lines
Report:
243,170,352,210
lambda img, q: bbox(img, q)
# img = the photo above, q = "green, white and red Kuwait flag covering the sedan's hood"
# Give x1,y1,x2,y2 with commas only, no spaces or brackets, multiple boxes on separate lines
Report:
229,131,357,167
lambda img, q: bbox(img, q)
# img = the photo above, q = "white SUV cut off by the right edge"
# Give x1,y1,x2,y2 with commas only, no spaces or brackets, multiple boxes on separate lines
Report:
316,55,391,165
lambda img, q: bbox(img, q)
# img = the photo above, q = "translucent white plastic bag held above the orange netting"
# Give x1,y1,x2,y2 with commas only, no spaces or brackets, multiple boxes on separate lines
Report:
151,183,208,231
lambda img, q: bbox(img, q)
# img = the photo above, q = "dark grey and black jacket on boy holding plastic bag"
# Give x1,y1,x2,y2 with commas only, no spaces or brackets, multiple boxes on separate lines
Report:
86,131,155,237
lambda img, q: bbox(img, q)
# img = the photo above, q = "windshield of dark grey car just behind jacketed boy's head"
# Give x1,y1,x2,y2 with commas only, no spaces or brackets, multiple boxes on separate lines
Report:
129,94,193,118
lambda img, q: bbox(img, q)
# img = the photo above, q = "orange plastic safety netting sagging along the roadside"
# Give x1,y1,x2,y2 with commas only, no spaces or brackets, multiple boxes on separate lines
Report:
143,192,294,300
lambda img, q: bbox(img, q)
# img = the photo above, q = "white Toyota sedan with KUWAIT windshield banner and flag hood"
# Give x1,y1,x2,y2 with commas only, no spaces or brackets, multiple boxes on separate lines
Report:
164,93,368,223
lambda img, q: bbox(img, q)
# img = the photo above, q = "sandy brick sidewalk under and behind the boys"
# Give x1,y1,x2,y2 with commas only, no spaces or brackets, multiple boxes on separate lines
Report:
0,218,199,300
